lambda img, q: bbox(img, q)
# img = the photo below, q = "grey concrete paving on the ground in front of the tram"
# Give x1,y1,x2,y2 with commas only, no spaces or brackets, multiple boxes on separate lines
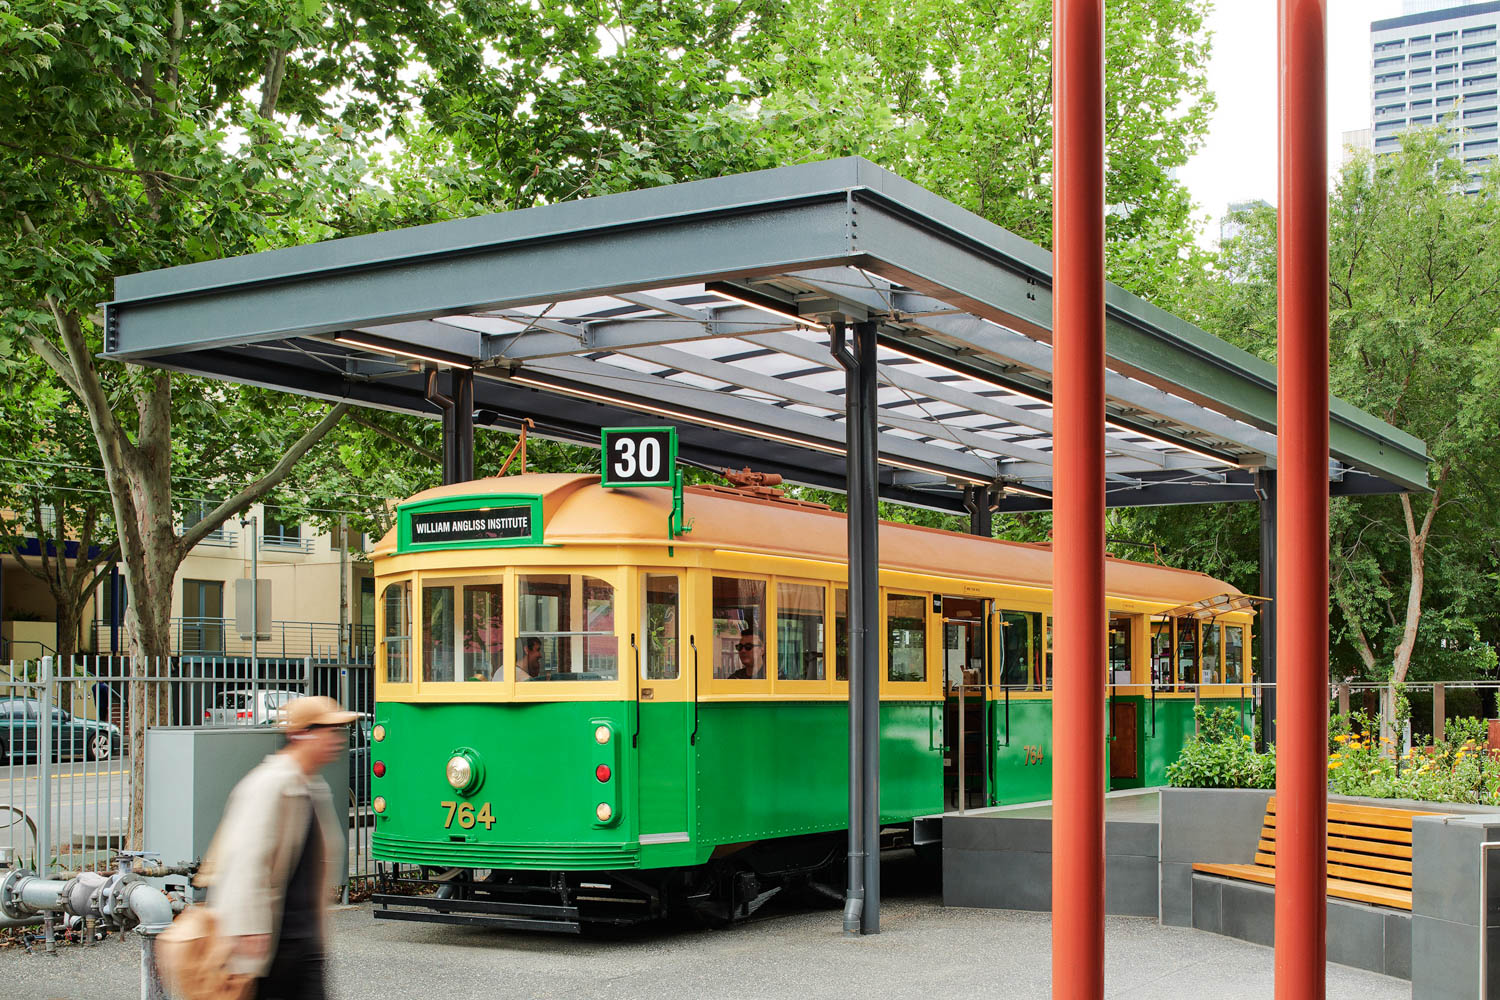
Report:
0,895,1412,1000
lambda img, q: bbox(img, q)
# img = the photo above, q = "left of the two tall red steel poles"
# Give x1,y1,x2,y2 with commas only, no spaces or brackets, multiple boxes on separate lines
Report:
1052,0,1106,1000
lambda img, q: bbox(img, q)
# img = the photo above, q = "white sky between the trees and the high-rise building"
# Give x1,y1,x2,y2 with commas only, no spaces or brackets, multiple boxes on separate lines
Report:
1178,0,1401,235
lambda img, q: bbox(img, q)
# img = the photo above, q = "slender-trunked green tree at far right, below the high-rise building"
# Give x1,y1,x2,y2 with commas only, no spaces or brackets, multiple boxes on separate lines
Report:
1182,133,1500,707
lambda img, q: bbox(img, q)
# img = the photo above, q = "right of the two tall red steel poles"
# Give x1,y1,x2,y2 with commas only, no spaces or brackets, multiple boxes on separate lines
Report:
1277,0,1328,1000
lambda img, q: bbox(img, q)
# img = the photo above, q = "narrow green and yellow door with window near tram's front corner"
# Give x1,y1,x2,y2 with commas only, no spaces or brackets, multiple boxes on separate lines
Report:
636,573,696,844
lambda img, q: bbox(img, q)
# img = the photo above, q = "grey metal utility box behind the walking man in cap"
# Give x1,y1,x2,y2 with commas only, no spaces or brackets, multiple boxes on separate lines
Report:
146,726,350,882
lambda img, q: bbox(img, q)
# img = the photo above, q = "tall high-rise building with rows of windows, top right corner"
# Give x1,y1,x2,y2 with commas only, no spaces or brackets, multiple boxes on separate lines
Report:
1370,0,1500,190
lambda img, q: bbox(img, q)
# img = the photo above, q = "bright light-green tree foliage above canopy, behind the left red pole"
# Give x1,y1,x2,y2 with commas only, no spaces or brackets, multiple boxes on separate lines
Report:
749,0,1214,306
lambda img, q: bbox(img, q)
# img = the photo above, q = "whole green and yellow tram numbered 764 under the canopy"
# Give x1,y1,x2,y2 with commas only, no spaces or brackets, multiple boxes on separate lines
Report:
371,474,1251,930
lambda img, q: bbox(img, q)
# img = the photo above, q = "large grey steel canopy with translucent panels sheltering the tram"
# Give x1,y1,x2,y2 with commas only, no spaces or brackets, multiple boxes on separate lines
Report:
104,157,1428,510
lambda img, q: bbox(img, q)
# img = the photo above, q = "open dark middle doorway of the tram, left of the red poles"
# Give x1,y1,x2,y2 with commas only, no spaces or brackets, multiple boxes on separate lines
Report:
942,597,990,810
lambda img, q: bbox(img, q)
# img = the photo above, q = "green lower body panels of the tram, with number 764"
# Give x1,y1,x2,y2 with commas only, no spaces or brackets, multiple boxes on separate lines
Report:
372,697,1242,871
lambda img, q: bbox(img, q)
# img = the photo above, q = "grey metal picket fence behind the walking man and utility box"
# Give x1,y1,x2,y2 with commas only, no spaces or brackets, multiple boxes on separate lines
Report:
0,655,375,882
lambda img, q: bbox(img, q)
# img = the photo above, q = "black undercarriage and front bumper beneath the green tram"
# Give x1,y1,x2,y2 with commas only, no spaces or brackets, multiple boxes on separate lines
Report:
372,826,912,934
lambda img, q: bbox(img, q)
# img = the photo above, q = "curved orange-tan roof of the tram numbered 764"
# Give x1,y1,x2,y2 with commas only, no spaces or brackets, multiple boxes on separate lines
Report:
374,472,1254,605
